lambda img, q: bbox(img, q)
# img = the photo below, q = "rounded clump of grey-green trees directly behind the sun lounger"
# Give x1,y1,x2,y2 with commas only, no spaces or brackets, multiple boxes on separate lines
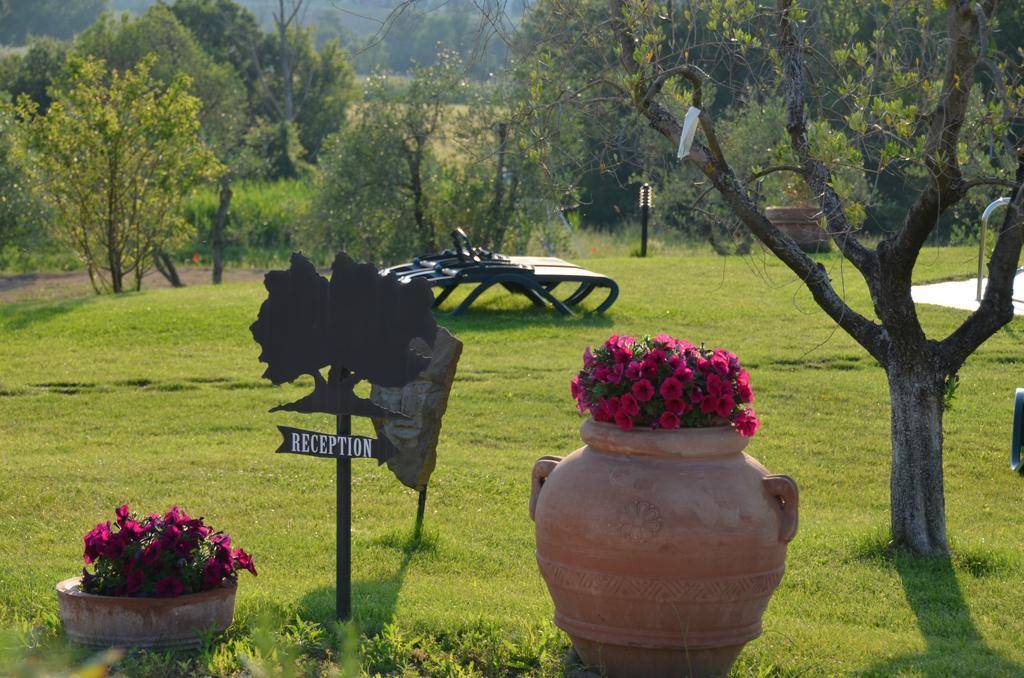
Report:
311,53,544,262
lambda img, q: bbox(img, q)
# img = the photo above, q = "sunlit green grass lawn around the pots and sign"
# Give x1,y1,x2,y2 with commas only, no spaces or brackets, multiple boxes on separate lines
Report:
0,249,1024,676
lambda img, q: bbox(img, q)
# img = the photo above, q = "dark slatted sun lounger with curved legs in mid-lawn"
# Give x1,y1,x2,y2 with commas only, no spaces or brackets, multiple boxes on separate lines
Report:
381,228,618,315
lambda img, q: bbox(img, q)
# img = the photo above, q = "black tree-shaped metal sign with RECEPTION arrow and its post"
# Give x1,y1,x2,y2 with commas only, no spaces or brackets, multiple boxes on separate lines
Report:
249,252,437,619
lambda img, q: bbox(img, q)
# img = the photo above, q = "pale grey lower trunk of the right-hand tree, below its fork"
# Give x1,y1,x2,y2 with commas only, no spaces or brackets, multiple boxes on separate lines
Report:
887,361,948,554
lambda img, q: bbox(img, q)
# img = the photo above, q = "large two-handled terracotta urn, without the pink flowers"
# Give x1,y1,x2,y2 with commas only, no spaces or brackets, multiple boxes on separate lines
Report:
529,420,798,678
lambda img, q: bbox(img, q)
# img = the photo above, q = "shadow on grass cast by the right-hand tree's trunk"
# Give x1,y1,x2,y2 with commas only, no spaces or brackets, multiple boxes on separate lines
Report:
864,552,1024,676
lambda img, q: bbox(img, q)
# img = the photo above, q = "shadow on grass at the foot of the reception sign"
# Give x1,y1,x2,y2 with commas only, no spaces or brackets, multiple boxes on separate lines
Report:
299,529,436,635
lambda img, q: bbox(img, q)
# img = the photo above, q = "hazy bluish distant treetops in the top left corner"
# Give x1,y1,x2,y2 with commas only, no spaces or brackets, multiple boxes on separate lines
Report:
0,0,106,45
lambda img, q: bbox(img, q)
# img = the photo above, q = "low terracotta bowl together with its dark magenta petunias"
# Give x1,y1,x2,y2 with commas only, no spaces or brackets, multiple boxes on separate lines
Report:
56,505,256,649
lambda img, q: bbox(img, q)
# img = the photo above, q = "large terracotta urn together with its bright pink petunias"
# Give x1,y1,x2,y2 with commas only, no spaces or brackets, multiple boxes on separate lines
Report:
530,334,798,676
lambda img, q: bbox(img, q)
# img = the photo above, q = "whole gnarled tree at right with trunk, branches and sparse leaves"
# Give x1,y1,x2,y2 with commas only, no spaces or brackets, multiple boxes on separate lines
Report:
534,0,1024,553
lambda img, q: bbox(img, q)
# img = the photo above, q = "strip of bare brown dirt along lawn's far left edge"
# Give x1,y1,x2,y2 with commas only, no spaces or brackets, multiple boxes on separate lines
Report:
0,266,266,303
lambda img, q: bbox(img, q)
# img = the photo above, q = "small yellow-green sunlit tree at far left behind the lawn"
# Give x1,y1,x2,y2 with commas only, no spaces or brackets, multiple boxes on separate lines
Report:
17,57,219,293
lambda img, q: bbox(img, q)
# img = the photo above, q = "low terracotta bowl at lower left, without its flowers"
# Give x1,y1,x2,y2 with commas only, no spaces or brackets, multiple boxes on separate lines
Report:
57,577,238,649
